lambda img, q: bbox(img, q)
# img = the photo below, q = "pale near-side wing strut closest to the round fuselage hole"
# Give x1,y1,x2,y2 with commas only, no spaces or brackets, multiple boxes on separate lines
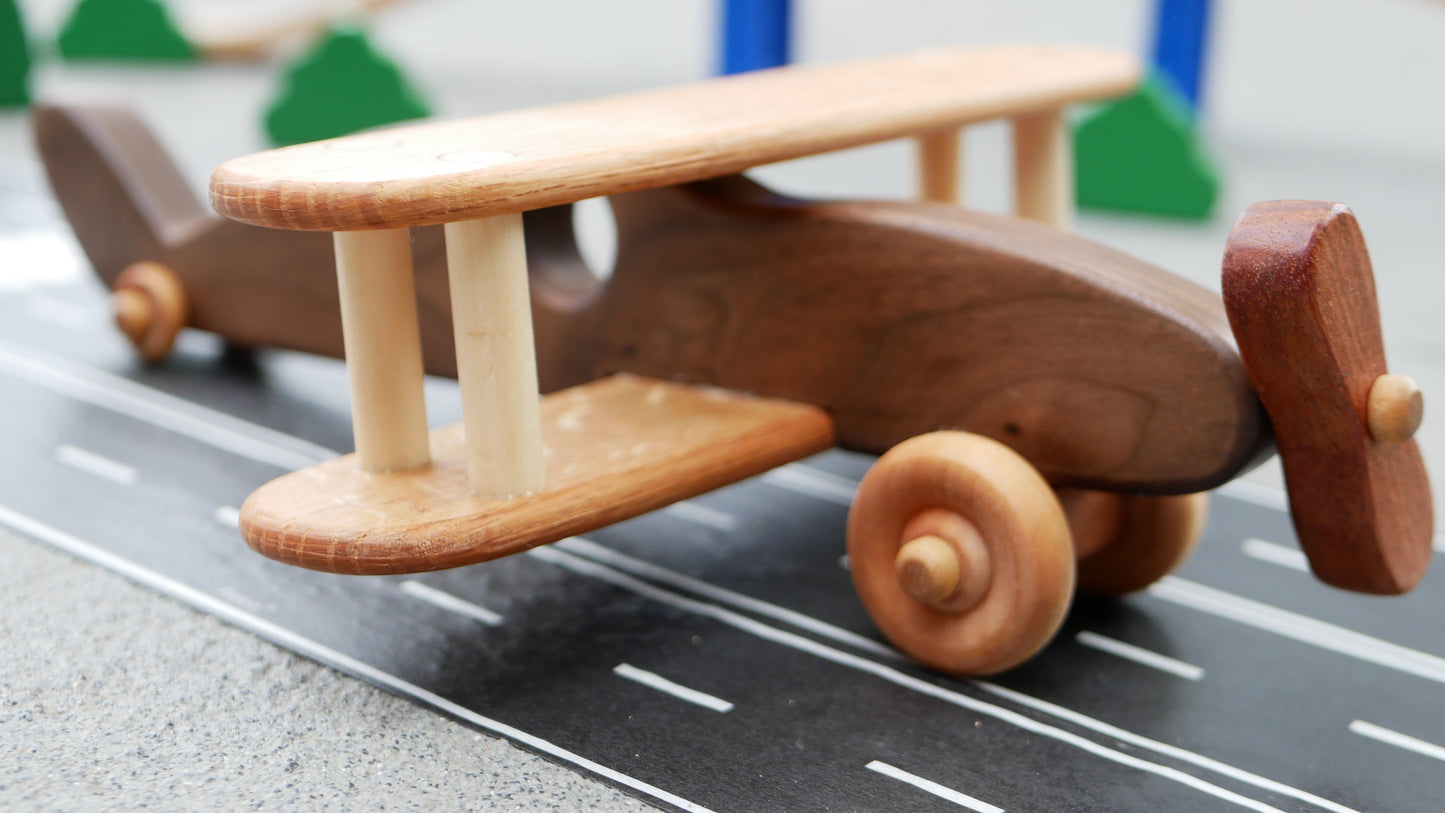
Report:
447,214,546,497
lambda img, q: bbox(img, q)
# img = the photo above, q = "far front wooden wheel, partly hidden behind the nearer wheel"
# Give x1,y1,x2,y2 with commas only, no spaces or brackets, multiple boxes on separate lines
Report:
1059,490,1209,595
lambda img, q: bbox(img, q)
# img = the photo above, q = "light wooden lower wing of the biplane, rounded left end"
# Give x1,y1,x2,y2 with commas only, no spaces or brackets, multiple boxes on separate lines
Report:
241,375,832,573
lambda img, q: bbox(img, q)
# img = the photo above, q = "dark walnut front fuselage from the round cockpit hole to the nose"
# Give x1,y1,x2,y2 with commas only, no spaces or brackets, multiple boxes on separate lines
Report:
574,178,1269,494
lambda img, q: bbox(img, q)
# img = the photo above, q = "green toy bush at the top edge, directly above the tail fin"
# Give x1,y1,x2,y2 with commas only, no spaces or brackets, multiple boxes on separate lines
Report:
59,0,197,59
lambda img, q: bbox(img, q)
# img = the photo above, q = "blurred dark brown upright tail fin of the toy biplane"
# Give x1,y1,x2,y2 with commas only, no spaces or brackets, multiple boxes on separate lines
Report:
32,103,218,283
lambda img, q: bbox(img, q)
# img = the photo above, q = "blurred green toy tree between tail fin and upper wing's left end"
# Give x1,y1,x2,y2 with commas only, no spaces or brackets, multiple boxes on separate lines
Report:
266,26,431,144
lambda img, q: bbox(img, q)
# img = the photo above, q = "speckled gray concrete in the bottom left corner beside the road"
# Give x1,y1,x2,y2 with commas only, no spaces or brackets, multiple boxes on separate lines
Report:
0,530,649,810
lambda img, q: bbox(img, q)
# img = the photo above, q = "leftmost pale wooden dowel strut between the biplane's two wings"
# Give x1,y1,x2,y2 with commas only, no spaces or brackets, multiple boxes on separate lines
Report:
335,228,431,471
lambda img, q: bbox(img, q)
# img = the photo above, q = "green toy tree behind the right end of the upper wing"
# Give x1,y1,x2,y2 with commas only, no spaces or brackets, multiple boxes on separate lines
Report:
1074,78,1220,218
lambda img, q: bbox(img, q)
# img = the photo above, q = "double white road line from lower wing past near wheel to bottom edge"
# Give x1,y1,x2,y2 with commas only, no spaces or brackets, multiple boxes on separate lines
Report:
527,546,1340,813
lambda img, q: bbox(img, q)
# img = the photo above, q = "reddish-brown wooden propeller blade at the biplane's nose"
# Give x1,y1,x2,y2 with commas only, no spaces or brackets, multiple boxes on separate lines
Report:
1224,201,1433,594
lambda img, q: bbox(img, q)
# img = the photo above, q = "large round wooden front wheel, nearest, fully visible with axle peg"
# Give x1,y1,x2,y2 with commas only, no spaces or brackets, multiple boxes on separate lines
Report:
848,432,1074,674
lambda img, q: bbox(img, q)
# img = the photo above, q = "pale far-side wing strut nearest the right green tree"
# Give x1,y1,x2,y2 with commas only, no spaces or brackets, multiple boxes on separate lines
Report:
1013,108,1074,230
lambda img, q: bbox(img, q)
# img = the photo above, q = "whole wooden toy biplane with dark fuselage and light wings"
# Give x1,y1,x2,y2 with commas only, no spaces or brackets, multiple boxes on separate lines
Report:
42,48,1432,673
